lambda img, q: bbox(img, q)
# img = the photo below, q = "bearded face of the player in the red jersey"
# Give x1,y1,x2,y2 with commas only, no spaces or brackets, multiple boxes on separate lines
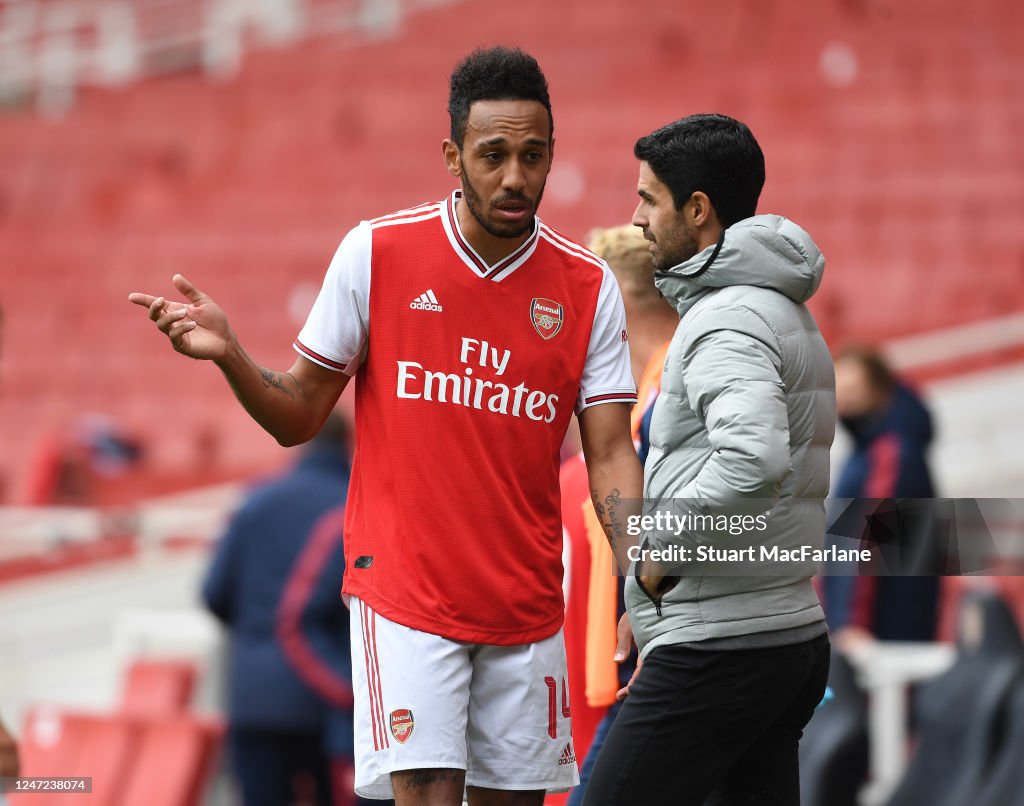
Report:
445,100,553,238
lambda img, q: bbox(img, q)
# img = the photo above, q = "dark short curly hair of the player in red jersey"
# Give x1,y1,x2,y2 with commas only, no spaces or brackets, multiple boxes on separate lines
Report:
449,46,555,149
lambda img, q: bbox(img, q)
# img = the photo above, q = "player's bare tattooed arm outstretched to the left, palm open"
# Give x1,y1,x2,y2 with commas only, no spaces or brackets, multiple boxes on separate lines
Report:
128,274,348,446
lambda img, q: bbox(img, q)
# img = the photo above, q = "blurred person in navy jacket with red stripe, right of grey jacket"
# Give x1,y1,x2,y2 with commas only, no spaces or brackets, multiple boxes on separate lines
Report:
821,345,940,648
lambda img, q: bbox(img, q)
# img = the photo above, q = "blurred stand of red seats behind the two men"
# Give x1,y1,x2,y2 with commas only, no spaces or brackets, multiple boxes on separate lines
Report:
0,0,1024,500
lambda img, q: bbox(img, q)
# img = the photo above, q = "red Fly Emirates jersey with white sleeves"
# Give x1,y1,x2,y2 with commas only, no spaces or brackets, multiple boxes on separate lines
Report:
295,192,636,644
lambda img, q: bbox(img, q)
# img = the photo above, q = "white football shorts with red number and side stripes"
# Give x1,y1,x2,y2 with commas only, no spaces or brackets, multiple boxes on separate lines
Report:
349,597,580,799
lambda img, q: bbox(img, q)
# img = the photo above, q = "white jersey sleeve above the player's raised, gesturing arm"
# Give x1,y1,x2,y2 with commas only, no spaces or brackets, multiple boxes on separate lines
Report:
294,221,372,375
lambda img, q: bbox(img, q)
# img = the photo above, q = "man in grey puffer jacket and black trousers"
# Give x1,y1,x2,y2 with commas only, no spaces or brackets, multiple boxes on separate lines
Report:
586,115,836,806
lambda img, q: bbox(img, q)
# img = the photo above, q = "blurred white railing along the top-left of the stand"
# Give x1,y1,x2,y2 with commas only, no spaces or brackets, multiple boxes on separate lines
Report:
0,0,458,117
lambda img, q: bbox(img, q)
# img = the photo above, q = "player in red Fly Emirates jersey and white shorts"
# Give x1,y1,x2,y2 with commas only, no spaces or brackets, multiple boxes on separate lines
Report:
129,47,642,806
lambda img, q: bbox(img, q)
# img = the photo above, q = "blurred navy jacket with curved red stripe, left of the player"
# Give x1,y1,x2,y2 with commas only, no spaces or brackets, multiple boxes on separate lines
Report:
202,446,352,756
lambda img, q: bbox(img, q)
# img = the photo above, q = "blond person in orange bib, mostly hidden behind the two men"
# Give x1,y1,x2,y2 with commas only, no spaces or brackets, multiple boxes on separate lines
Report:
560,224,679,806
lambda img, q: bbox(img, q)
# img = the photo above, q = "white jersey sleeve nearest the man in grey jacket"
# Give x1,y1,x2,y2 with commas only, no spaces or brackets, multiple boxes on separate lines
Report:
575,265,637,414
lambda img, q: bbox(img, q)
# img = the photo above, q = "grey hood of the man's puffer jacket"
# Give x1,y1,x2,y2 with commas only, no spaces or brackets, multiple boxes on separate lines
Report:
654,215,825,315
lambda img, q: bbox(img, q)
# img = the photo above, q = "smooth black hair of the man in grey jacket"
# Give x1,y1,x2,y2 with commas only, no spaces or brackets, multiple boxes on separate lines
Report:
633,115,765,226
